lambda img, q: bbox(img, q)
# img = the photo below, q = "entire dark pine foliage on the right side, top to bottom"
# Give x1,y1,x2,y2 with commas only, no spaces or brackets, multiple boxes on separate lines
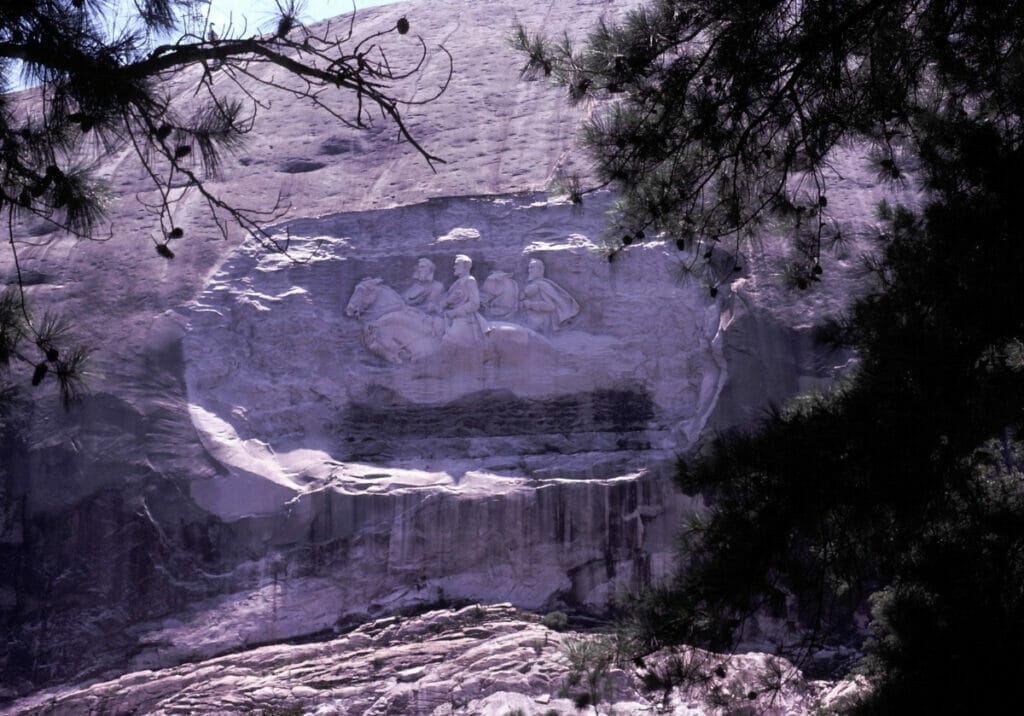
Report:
513,0,1024,713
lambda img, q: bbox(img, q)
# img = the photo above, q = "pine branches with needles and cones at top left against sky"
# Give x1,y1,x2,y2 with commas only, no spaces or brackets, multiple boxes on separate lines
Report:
0,0,451,401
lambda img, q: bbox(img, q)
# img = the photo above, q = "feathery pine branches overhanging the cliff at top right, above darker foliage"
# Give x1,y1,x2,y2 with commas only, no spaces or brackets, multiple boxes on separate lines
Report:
512,0,1024,276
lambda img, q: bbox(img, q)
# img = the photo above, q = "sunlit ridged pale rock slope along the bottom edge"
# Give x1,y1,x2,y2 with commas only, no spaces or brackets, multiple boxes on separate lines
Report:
4,604,863,716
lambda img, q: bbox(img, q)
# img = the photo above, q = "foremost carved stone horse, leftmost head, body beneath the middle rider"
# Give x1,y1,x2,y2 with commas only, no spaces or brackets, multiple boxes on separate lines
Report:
345,278,554,366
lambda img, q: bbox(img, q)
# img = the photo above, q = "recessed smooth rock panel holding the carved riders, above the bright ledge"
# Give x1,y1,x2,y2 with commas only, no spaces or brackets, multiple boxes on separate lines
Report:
186,190,731,474
